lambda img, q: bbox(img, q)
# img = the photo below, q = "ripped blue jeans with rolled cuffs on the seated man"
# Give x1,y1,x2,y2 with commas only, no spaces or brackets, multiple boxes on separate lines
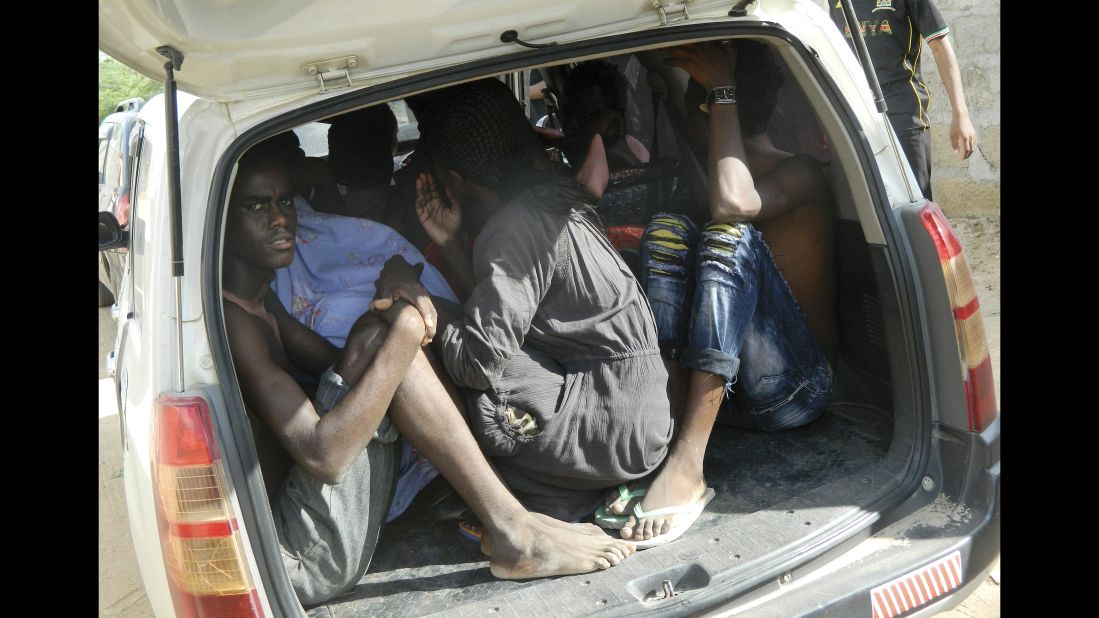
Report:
641,213,834,431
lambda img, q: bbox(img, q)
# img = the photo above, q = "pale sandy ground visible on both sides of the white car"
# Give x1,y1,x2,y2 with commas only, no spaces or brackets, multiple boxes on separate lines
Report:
99,217,1000,618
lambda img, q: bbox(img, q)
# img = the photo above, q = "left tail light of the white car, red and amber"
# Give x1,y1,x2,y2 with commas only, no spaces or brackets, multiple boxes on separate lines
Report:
153,395,263,618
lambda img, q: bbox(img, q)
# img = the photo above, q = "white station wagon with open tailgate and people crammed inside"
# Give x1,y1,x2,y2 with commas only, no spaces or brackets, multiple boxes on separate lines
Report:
99,0,1000,617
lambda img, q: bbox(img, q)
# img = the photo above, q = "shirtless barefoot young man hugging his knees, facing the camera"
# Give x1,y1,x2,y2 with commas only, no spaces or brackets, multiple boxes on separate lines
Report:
222,148,634,605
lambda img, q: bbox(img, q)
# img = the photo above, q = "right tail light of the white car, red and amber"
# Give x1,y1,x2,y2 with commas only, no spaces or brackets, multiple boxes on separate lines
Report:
920,201,999,431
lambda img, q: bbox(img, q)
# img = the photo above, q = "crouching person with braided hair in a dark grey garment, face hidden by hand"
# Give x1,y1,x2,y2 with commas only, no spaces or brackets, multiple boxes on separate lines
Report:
422,79,673,521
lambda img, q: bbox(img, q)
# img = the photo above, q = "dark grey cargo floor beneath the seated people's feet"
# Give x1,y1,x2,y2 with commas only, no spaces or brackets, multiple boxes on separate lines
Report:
310,395,892,617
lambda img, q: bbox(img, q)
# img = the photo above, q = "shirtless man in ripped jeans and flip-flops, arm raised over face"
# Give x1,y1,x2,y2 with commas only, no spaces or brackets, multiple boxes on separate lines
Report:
604,41,837,541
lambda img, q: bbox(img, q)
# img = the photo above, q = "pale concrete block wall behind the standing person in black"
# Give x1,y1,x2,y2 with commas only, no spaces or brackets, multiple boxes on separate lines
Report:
817,0,1000,217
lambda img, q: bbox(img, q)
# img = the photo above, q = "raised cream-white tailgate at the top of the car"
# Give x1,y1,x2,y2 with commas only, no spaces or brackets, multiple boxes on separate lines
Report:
99,0,747,101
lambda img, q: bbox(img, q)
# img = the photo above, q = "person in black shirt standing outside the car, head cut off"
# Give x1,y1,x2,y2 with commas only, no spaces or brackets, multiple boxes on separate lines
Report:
830,0,977,199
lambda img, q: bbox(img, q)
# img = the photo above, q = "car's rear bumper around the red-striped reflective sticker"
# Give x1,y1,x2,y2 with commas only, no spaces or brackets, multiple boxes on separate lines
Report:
707,413,1000,617
